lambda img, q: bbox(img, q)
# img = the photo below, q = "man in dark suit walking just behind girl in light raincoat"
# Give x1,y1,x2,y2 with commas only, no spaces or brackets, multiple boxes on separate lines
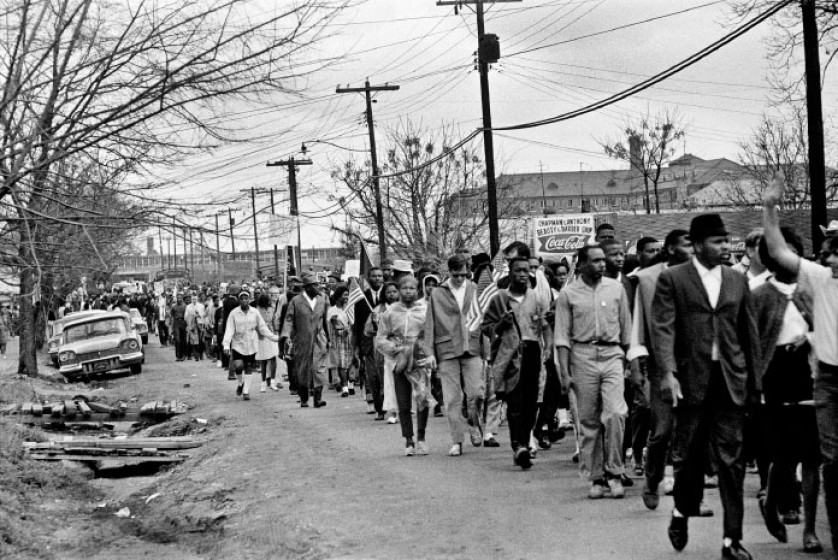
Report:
352,267,384,420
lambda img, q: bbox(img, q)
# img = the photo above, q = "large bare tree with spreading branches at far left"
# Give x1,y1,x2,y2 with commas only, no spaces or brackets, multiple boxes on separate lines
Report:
0,0,350,373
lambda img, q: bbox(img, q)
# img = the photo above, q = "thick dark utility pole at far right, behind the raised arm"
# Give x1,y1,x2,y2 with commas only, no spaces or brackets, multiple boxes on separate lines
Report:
801,0,826,253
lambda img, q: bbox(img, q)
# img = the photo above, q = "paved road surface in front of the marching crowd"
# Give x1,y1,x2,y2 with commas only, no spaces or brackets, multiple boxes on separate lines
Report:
59,340,829,560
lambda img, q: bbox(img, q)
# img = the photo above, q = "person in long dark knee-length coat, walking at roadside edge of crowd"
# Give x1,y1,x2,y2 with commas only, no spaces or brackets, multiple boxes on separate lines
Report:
281,273,329,408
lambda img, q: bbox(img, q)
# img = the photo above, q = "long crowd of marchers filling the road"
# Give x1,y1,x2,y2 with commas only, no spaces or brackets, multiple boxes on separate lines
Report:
150,182,838,560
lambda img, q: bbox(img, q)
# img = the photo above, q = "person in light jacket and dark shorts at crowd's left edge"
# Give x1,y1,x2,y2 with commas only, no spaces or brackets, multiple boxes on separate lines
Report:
222,290,279,401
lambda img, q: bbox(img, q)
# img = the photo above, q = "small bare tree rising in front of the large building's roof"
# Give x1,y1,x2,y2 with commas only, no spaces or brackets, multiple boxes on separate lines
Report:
599,110,686,214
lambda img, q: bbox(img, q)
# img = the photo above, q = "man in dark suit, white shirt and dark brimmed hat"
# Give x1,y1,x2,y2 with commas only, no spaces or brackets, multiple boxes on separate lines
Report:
652,214,759,560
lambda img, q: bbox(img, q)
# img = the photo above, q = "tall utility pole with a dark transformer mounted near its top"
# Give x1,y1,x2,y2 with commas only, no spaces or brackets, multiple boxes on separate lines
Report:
436,0,521,257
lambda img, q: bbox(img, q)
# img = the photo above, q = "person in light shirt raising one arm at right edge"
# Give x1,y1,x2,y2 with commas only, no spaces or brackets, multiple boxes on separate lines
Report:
763,177,838,551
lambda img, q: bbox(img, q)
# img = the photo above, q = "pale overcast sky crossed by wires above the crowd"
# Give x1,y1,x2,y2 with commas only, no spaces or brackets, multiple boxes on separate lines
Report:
153,0,838,254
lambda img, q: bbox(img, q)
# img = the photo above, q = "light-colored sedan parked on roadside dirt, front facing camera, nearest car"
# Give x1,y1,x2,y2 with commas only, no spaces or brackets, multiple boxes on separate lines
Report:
58,311,145,380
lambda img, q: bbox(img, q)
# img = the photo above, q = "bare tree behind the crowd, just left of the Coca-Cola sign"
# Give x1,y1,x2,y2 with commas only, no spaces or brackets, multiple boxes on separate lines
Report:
332,121,520,267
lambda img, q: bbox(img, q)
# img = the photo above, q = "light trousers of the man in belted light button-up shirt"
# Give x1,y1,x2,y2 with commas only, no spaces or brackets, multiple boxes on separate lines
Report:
570,344,628,480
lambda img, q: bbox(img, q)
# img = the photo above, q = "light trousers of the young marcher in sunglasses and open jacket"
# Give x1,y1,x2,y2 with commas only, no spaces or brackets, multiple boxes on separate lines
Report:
437,356,485,443
